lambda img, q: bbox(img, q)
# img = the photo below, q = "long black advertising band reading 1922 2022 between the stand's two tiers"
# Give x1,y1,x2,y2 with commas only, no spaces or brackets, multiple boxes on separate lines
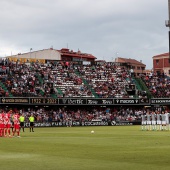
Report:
0,97,170,106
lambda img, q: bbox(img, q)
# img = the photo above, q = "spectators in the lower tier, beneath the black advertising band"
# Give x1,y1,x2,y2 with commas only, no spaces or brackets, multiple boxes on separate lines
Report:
1,107,149,123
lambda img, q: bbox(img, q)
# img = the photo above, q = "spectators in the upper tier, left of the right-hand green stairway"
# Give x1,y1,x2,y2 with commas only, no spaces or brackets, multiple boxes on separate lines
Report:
0,59,142,98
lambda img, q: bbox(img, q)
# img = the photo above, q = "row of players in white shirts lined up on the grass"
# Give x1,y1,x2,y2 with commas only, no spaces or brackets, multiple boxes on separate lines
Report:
141,110,170,130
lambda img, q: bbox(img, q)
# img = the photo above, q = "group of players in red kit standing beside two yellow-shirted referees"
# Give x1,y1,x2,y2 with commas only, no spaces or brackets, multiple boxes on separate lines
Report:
0,110,20,137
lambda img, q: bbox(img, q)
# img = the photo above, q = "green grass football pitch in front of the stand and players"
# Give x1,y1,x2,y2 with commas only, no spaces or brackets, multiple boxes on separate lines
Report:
0,126,170,170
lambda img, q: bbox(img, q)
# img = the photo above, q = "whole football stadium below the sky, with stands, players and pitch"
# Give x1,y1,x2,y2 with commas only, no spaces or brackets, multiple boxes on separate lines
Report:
0,1,170,170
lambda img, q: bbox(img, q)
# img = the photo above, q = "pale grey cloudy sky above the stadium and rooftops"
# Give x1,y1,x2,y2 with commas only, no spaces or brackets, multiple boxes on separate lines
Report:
0,0,169,69
